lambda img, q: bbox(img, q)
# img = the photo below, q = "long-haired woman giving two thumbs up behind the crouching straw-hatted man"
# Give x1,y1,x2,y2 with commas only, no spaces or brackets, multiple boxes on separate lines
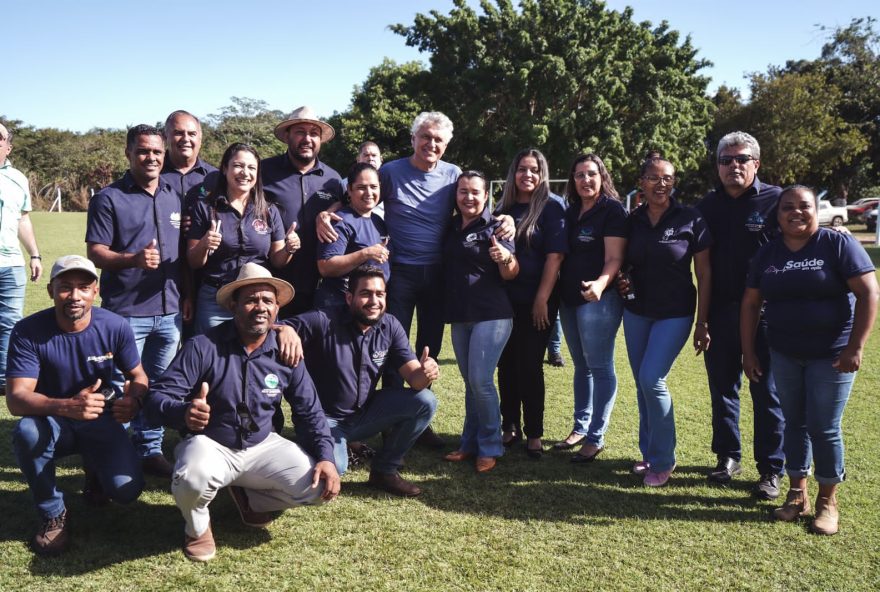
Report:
187,143,299,335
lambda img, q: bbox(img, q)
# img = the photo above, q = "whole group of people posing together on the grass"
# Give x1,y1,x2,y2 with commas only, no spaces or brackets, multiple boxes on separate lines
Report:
0,107,878,561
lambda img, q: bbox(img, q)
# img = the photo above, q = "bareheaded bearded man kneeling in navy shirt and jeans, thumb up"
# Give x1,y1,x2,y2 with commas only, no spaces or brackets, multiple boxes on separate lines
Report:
285,266,440,497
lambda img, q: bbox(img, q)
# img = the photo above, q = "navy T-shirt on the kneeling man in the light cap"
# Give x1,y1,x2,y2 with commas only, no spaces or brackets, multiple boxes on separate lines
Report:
6,306,140,399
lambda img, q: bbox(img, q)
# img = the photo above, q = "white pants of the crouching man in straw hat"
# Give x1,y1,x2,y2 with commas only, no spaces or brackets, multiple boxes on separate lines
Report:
171,432,324,537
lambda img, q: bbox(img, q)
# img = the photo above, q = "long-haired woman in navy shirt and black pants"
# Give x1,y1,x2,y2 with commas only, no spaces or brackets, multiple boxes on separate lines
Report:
495,148,568,459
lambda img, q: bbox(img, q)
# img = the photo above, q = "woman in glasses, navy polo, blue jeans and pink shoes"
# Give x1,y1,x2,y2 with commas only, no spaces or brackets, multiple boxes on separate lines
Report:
621,158,711,487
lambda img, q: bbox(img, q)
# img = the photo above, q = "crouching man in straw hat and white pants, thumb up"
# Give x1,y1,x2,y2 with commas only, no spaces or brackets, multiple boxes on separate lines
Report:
146,263,339,561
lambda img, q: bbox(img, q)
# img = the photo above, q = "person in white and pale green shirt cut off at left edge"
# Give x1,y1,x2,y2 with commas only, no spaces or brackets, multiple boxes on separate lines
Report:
0,123,43,396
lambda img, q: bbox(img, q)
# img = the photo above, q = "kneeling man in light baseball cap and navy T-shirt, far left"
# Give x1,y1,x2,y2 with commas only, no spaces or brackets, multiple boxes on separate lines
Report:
6,255,147,555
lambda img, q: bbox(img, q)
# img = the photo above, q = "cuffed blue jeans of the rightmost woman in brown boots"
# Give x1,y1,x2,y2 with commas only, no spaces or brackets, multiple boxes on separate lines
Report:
770,350,856,485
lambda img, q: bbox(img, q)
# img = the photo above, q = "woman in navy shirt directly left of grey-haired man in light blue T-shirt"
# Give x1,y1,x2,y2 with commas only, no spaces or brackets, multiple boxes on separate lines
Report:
315,162,391,311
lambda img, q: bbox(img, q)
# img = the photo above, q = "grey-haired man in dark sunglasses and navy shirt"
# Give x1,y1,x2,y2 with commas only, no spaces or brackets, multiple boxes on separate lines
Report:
697,131,784,499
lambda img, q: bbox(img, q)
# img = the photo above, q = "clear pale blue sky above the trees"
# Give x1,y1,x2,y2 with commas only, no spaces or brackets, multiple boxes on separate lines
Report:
0,0,880,131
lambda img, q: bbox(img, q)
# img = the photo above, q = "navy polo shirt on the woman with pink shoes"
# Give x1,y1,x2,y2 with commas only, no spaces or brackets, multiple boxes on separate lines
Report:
624,197,712,319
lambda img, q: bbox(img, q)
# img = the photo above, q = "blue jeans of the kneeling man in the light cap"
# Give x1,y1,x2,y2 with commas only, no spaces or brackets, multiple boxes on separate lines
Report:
12,413,144,519
